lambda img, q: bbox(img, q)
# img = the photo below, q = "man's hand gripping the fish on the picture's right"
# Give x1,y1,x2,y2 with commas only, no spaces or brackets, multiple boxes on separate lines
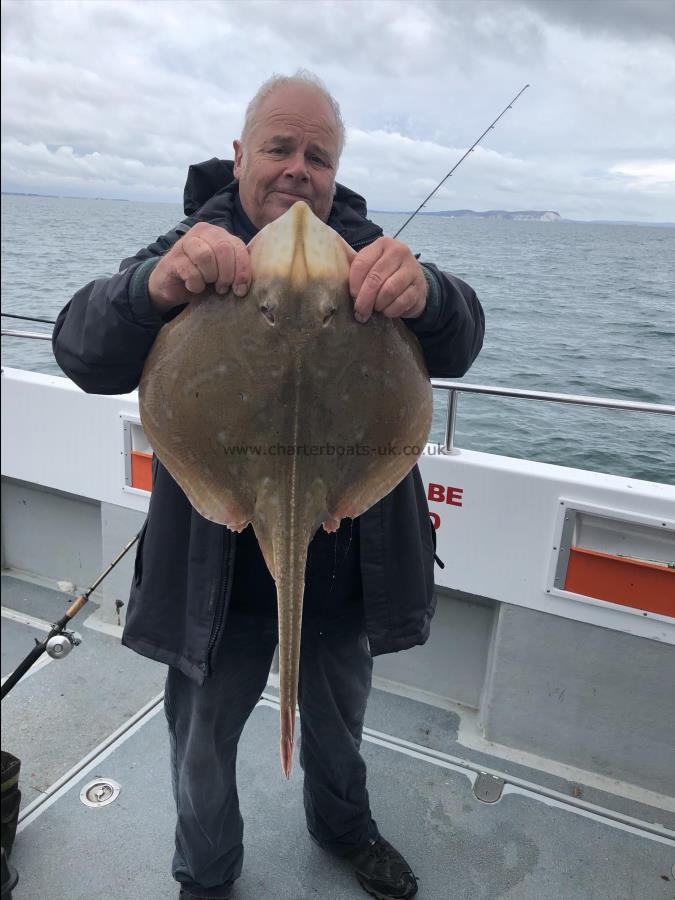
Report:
349,238,427,322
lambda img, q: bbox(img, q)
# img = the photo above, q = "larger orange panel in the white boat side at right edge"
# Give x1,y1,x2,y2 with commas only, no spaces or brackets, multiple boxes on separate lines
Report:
565,547,675,618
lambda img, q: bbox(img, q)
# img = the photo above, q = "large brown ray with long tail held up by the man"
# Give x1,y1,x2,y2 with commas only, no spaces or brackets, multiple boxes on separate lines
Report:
140,202,432,777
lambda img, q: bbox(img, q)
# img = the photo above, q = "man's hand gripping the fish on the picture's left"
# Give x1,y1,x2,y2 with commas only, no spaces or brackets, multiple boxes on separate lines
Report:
148,222,251,313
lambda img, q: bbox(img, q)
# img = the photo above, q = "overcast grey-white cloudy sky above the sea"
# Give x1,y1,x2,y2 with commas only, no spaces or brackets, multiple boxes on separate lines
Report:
2,0,675,222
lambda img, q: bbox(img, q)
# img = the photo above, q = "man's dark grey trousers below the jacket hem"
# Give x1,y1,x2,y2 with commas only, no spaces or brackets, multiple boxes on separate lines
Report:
164,614,378,897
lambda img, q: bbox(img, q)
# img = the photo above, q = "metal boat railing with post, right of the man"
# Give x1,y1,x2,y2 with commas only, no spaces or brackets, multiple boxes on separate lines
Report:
431,378,675,453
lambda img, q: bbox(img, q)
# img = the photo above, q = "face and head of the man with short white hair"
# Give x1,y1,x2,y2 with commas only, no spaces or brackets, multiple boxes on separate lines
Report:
234,84,339,228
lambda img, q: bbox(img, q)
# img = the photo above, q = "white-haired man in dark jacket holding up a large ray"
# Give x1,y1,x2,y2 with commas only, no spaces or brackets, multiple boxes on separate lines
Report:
54,73,483,900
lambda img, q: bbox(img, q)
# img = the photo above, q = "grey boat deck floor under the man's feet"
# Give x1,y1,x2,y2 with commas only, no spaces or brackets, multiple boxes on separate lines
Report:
2,575,675,900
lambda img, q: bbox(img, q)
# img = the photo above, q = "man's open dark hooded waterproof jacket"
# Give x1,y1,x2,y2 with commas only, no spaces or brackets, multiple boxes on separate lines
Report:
53,159,484,683
